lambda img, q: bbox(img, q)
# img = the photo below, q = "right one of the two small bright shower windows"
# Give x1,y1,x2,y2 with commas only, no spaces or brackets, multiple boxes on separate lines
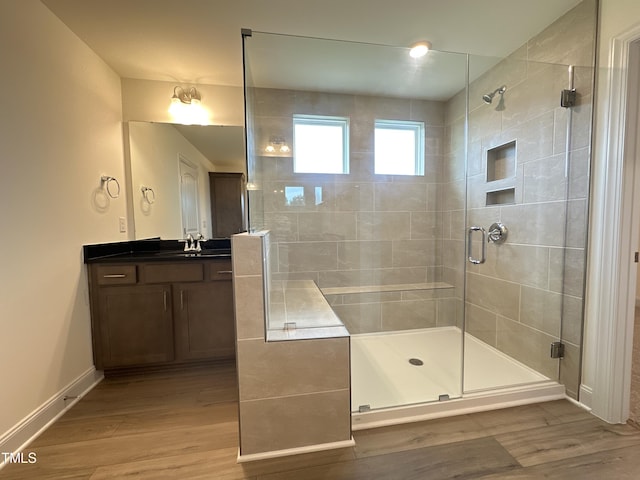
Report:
374,120,424,175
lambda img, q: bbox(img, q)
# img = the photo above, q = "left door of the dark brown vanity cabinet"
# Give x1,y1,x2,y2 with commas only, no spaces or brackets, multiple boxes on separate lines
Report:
96,285,174,368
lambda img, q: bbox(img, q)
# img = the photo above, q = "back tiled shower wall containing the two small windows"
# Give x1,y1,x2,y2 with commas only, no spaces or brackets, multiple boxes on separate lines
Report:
250,89,459,333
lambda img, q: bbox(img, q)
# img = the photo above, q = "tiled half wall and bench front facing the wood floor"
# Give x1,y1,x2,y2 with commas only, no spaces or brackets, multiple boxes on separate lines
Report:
231,234,352,461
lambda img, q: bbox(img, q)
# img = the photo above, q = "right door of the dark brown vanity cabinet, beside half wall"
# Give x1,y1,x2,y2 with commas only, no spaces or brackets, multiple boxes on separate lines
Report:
174,280,235,360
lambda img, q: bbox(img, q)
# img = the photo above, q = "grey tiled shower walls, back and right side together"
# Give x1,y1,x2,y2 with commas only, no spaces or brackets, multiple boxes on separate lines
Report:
249,0,597,396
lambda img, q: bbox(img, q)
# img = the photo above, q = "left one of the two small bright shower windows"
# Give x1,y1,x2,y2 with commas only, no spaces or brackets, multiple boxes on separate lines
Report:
293,115,349,173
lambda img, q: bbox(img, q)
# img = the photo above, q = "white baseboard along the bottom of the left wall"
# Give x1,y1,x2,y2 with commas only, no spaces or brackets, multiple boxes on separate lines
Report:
0,367,104,469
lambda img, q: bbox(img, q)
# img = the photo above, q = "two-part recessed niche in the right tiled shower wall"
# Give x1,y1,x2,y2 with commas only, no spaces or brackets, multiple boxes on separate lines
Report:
486,140,516,205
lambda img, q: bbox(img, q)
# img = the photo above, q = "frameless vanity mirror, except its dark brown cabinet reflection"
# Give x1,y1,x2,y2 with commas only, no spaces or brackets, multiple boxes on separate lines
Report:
124,121,246,240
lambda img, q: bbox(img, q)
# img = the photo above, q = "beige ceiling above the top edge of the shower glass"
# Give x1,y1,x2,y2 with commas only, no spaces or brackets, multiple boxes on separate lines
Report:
42,0,580,90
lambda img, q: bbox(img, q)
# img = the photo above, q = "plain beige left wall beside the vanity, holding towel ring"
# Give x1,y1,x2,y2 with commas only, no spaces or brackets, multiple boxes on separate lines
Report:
0,0,127,439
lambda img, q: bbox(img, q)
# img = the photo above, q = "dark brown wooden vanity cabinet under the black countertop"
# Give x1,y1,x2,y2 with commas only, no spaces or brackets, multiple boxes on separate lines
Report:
88,257,235,370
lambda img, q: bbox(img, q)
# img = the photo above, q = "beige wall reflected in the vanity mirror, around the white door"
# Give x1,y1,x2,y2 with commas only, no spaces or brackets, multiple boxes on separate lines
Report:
129,122,216,239
